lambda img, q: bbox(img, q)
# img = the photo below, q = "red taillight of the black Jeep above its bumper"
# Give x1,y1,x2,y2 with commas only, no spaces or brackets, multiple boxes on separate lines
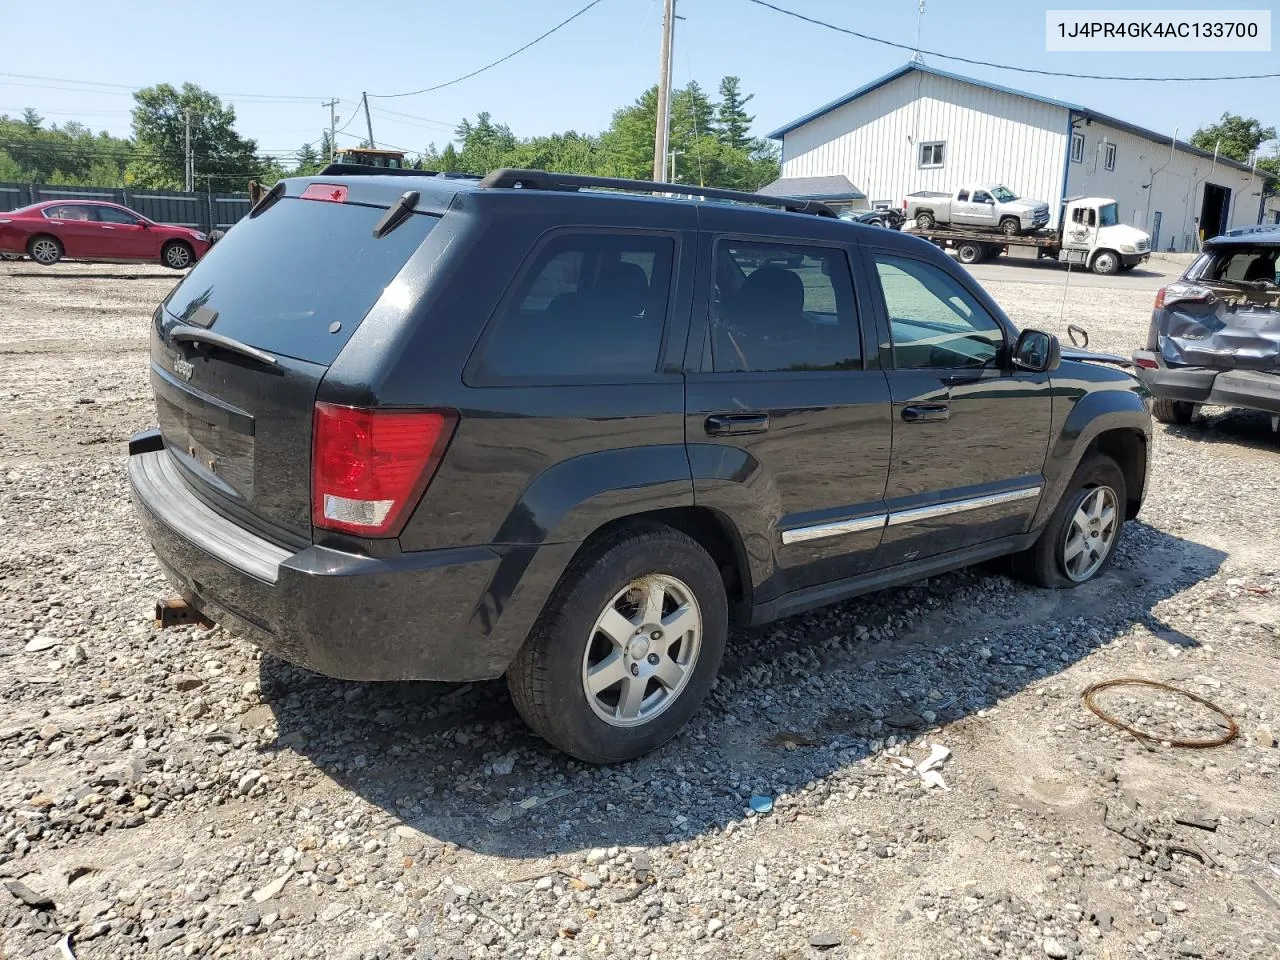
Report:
311,403,458,536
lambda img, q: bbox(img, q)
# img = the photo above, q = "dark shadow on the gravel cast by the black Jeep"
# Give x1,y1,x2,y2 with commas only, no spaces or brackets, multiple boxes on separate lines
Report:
260,522,1225,858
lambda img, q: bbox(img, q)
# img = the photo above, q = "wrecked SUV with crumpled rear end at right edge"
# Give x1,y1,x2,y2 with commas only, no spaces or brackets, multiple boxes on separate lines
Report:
1133,224,1280,431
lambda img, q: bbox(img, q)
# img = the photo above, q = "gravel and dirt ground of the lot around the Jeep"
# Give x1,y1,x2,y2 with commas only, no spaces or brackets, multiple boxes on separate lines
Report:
0,257,1280,960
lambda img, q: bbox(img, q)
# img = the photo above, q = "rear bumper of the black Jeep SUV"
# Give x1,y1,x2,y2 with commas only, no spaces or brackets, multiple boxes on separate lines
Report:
129,435,513,681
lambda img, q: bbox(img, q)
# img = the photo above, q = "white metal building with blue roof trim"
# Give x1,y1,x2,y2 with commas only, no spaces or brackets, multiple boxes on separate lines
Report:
769,63,1270,251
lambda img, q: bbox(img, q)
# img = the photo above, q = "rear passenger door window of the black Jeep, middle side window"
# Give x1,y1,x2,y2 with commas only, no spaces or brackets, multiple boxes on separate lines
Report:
710,241,863,372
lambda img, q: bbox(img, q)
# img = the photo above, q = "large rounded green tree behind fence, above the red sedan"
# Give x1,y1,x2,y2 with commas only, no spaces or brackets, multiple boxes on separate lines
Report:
128,83,267,192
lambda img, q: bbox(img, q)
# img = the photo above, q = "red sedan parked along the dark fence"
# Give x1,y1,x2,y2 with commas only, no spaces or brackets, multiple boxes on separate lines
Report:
0,200,209,270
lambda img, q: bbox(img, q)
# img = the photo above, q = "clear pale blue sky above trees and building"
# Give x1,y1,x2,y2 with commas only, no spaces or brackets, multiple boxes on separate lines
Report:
0,0,1280,161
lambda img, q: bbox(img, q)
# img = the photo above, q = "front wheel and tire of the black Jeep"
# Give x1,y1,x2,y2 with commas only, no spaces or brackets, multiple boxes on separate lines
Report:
1012,453,1126,589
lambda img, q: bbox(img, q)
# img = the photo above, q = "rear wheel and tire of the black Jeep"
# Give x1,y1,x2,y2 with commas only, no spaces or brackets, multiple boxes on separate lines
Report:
507,524,728,764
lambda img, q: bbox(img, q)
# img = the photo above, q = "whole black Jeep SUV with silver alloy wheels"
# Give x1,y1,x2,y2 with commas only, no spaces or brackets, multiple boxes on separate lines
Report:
129,168,1151,763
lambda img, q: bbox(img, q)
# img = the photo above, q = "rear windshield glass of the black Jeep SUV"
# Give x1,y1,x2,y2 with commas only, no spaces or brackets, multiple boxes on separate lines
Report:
165,198,439,365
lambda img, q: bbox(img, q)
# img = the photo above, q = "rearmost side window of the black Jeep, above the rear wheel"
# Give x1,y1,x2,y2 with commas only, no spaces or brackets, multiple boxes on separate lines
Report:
479,233,676,379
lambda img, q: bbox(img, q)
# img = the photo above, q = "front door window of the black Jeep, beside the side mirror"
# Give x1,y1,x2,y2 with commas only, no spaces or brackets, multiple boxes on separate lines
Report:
876,253,1005,370
